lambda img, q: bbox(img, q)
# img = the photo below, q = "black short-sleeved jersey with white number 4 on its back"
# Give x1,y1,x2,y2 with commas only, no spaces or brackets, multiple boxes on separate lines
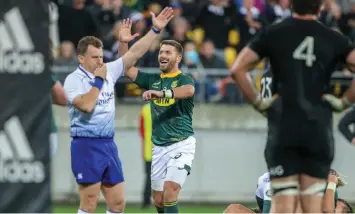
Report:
249,18,354,120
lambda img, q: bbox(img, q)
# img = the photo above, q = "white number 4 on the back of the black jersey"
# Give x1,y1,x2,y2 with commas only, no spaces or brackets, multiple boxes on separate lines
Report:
293,36,316,67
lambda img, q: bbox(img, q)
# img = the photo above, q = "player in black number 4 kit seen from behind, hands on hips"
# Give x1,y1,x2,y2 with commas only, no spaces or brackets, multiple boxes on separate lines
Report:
231,0,355,213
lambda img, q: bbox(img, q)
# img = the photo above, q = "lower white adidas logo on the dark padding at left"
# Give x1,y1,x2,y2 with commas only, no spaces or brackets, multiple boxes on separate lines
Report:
0,117,45,183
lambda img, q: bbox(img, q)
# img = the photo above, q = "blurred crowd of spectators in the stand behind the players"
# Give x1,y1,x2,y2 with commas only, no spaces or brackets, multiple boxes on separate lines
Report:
50,0,355,104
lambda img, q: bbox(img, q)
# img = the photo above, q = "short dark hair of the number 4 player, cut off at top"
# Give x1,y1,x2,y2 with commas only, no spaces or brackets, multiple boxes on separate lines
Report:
291,0,323,15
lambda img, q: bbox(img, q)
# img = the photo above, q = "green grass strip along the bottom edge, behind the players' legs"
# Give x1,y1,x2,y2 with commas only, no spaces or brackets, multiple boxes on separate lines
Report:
53,204,253,213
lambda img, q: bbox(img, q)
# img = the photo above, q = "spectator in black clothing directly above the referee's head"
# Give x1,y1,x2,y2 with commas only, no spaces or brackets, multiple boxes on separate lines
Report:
58,0,100,47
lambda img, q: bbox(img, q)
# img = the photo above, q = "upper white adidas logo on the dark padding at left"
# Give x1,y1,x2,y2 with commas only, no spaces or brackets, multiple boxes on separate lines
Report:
0,7,45,74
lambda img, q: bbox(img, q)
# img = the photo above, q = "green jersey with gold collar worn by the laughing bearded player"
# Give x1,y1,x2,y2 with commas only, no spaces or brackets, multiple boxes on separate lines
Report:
134,70,195,146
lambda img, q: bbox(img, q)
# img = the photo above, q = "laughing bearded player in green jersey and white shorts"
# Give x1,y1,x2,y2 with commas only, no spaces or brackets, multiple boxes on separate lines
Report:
129,40,196,213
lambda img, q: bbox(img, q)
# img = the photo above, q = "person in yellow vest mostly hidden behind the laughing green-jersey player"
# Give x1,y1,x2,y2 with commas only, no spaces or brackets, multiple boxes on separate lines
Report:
139,103,153,208
